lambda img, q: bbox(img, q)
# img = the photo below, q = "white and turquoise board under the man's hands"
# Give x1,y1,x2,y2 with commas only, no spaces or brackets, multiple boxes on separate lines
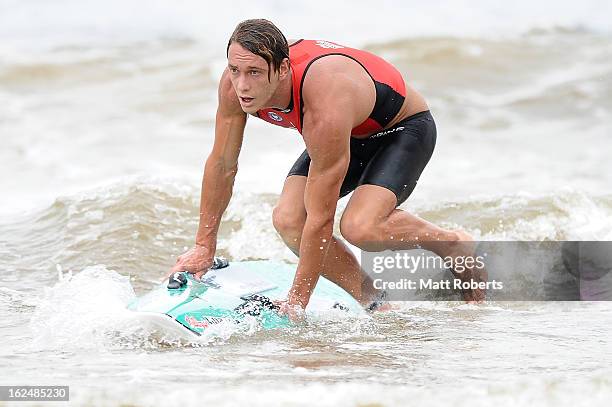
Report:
128,258,363,339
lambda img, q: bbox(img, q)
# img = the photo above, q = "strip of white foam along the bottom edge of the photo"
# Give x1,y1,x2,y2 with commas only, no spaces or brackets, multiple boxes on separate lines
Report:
61,372,611,407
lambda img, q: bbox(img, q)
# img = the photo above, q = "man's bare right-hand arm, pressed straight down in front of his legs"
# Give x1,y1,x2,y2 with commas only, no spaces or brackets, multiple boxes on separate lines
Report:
288,82,355,309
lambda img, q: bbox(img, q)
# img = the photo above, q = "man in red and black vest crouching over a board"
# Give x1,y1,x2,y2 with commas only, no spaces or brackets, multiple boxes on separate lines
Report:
171,19,480,318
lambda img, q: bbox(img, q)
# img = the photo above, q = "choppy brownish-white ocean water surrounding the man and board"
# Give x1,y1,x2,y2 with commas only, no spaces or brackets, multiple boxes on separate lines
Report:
0,0,612,406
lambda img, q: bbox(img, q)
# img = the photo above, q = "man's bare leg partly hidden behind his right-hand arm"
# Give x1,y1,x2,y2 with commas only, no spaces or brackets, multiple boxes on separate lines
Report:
272,175,378,305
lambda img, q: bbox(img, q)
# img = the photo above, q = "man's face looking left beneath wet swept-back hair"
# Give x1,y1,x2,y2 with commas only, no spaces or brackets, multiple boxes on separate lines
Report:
227,42,280,114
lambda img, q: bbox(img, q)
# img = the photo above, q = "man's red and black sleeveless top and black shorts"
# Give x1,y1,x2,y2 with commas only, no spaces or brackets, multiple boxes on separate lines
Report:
256,40,436,205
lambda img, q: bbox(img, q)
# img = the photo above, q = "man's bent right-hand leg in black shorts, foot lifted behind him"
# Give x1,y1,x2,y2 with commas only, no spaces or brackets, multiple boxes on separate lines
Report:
340,111,486,301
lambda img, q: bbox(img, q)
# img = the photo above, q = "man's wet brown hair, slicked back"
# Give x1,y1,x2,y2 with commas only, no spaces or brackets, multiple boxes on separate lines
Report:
226,18,289,81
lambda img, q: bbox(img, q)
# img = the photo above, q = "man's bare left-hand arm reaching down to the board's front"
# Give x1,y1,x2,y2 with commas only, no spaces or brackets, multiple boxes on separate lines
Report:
170,70,247,279
